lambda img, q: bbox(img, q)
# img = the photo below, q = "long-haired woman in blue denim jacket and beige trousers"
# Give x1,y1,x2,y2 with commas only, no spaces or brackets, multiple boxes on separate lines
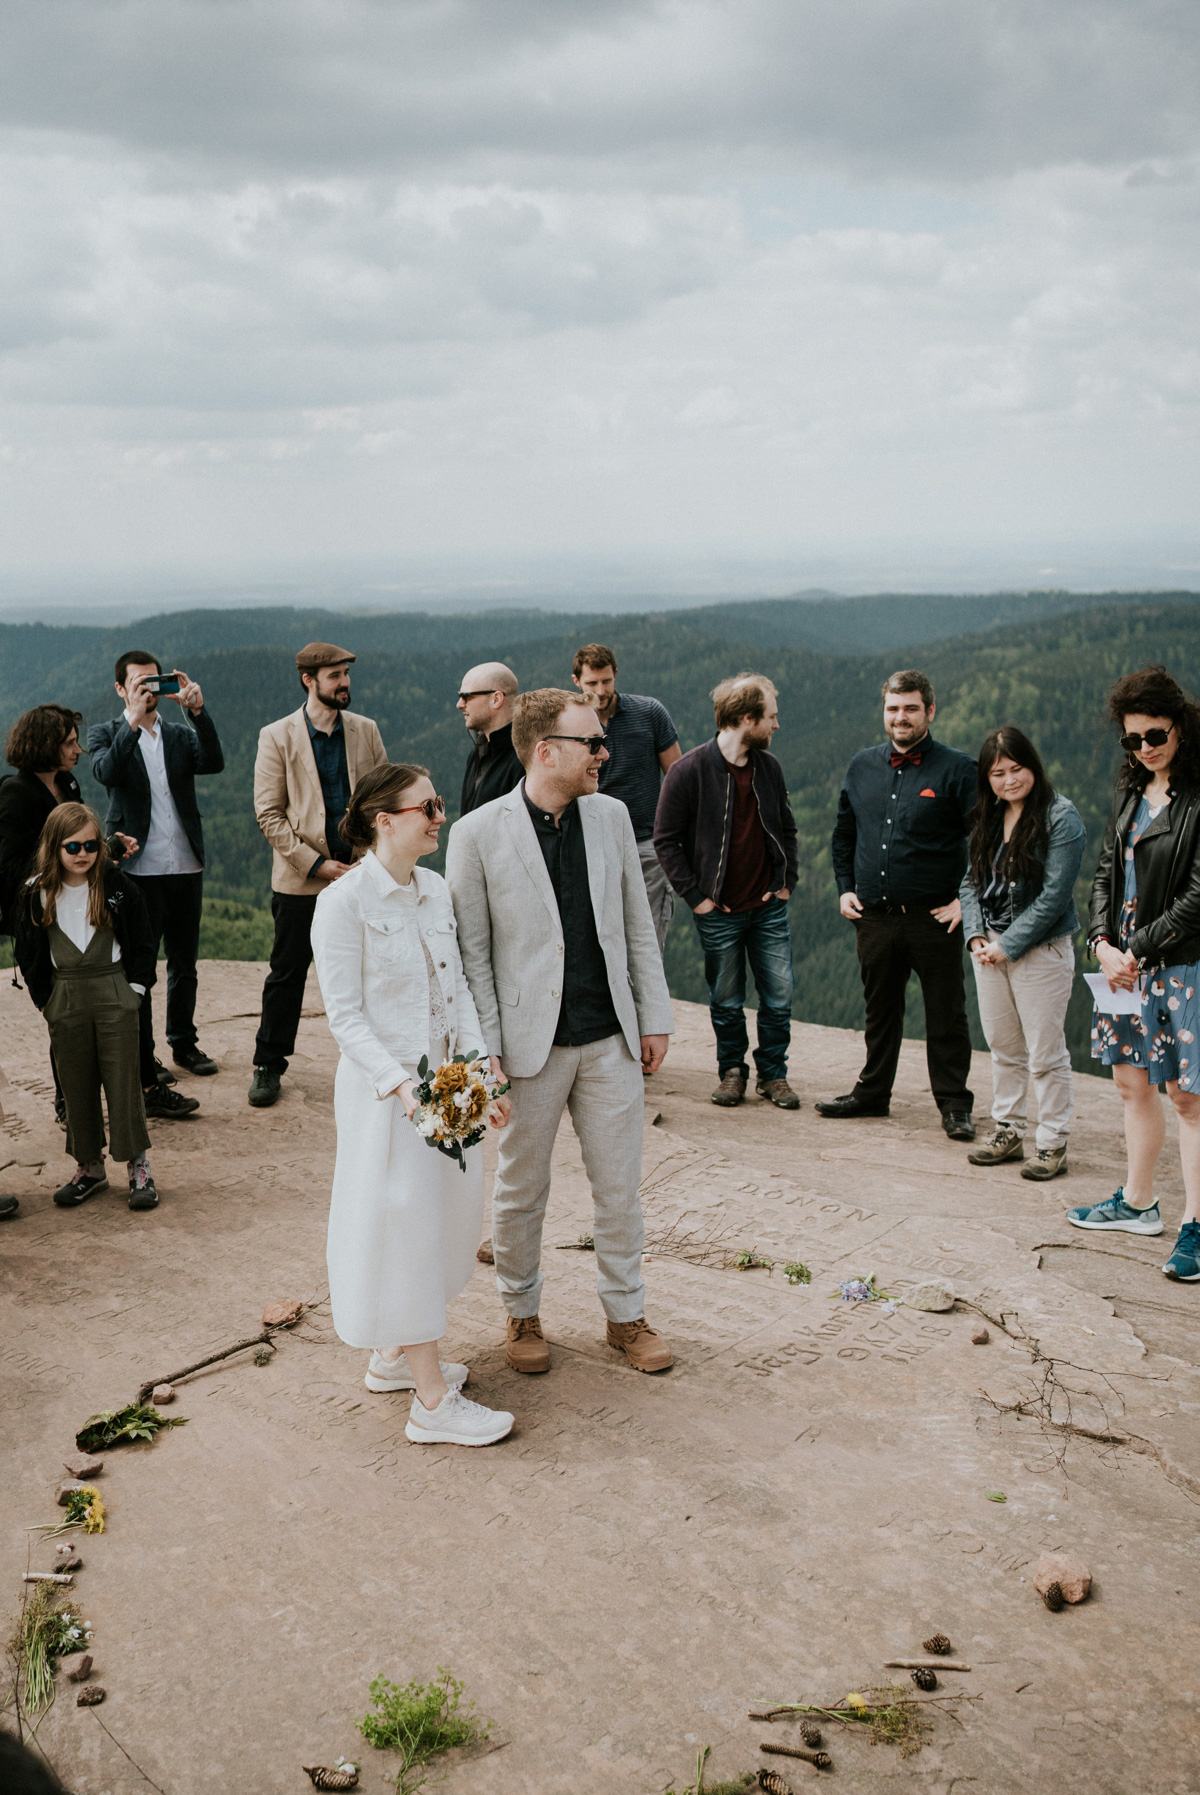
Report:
958,723,1087,1179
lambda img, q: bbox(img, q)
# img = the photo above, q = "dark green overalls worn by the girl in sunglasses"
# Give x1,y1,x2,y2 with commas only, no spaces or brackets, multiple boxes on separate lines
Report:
45,923,151,1165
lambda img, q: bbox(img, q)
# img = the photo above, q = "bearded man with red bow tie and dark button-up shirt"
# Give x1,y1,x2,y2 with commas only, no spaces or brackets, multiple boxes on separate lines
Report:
816,668,978,1140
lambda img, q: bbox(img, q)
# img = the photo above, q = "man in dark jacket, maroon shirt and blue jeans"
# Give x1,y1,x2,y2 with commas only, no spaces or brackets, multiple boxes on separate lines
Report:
655,673,800,1109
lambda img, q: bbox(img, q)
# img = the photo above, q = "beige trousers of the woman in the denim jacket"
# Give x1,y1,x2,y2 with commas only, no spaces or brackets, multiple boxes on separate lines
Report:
972,932,1074,1152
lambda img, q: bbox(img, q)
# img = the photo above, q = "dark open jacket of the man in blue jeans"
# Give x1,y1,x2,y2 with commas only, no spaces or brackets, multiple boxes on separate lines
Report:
655,736,800,910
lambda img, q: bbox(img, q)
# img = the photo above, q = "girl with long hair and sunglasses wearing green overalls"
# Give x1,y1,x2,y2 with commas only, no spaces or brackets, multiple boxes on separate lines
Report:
16,804,158,1210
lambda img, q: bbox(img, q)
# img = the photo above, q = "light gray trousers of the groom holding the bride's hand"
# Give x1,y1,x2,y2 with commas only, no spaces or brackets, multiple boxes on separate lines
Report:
491,1034,646,1321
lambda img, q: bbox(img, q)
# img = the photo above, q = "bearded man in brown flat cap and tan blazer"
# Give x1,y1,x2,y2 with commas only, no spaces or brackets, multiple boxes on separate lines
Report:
249,643,387,1109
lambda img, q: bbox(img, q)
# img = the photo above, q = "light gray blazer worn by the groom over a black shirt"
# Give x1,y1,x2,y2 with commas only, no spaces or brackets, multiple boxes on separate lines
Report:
447,779,674,1079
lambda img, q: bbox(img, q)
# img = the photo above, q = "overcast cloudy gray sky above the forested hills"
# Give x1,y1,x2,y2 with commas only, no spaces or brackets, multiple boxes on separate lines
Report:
0,0,1200,596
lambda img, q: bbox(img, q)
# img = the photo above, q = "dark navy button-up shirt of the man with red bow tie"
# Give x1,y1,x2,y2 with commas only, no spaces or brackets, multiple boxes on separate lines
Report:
832,736,979,910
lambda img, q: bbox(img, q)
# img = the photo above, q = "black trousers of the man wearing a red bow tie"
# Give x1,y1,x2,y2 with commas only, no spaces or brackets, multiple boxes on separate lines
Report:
854,908,974,1109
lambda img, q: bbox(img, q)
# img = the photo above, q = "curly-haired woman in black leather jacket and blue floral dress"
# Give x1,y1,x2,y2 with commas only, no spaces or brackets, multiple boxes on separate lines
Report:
1067,666,1200,1283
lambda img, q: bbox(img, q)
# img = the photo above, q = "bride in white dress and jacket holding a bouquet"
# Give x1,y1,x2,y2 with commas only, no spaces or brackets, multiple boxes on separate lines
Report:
312,765,513,1445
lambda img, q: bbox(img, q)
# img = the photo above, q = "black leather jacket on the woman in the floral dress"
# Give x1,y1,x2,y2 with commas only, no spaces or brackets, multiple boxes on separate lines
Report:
1087,786,1200,966
